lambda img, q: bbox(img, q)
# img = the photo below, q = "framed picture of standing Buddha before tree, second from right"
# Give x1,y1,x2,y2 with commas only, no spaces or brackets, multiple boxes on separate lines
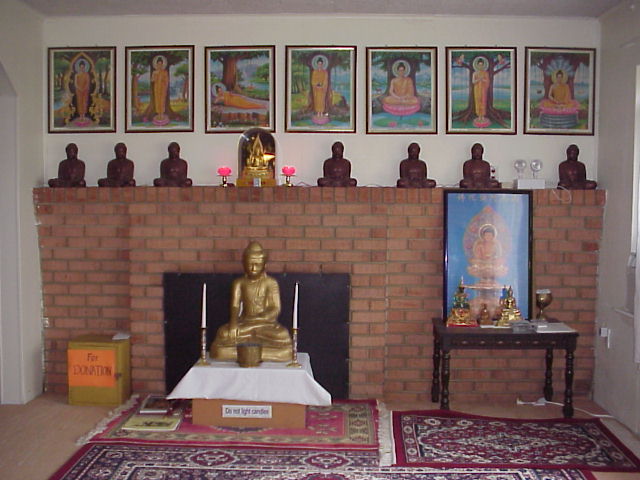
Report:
446,47,517,135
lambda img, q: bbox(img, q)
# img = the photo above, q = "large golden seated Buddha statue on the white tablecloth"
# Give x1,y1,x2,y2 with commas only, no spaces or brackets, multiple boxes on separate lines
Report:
209,241,292,362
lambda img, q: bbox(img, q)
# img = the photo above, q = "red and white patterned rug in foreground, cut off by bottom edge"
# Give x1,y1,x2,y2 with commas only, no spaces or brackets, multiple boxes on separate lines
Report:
50,443,594,480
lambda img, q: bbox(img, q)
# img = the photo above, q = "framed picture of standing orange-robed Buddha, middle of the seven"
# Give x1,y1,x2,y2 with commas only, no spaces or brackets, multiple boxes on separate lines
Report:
285,45,356,133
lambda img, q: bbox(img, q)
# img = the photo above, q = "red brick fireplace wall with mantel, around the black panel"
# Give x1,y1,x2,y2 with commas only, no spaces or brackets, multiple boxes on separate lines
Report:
34,187,605,402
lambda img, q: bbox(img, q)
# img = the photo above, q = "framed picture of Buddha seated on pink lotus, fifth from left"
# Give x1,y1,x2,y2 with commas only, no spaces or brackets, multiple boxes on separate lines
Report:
366,47,438,134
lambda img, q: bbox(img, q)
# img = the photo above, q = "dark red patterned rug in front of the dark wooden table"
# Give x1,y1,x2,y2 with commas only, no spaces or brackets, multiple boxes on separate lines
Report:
393,410,640,472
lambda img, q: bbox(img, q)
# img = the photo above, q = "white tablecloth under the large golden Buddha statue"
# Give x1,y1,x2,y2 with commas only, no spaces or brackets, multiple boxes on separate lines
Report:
167,353,331,405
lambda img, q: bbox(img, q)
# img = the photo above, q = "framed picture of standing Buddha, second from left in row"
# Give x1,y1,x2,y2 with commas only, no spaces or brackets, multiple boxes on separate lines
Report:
125,45,194,133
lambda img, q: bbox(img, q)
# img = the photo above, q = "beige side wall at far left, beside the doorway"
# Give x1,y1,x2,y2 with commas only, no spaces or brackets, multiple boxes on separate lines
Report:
0,0,45,403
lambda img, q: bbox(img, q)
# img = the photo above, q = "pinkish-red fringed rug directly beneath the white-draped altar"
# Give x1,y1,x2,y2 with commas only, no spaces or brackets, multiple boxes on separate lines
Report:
78,398,384,452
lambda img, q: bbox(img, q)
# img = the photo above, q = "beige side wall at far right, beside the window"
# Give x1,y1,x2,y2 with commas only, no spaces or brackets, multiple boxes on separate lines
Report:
594,1,640,433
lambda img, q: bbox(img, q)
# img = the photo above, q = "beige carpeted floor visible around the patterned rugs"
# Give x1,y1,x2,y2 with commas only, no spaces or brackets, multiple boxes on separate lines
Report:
0,393,640,480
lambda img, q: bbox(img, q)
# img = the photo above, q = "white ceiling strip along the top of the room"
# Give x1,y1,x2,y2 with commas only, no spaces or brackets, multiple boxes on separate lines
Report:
15,0,626,17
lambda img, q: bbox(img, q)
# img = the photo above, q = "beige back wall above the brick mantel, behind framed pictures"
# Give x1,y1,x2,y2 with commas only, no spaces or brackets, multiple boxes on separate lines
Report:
43,16,600,185
